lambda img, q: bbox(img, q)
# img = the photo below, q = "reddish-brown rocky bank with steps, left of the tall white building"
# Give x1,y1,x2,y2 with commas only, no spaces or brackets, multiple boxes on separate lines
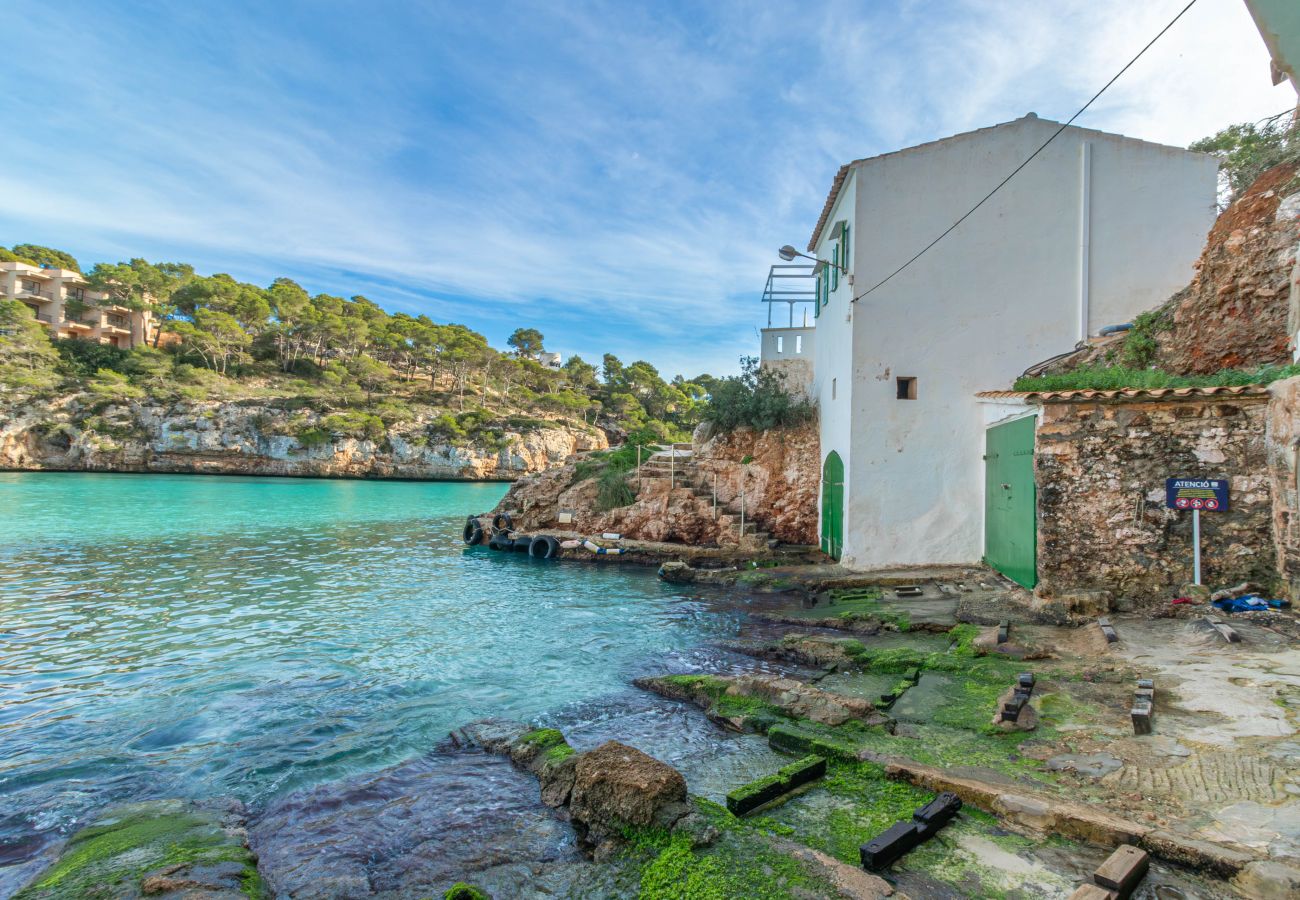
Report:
498,421,820,546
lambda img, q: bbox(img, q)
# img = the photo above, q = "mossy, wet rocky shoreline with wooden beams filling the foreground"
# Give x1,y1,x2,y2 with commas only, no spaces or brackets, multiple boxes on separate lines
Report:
18,568,1300,900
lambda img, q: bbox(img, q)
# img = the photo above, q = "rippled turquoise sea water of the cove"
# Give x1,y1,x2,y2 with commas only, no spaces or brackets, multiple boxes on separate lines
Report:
0,473,736,866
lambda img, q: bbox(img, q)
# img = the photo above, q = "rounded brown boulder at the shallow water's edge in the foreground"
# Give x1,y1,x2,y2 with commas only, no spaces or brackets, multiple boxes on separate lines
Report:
569,740,690,847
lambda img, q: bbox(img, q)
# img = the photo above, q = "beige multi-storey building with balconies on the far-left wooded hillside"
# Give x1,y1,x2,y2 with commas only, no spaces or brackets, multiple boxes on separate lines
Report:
0,263,151,349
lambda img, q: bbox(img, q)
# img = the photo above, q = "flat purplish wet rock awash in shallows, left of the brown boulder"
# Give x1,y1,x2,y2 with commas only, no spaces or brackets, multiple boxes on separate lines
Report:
250,750,579,897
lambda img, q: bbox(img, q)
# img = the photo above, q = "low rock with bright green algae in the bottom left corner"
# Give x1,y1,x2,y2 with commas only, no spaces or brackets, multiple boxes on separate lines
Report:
16,800,265,900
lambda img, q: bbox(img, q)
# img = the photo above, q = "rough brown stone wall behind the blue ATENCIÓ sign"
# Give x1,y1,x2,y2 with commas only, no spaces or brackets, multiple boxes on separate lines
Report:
1035,391,1277,602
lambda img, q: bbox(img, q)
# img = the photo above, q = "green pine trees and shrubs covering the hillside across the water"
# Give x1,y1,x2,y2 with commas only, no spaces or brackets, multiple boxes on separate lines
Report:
0,245,738,450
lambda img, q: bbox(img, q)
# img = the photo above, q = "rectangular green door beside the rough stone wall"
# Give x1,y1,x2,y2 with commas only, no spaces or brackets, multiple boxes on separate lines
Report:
984,416,1039,588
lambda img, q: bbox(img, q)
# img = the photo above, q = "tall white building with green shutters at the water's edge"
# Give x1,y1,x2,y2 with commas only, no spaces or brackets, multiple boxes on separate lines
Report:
790,113,1218,571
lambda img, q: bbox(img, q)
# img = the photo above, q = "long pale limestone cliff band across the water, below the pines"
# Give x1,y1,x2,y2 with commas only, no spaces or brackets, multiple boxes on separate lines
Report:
0,394,608,480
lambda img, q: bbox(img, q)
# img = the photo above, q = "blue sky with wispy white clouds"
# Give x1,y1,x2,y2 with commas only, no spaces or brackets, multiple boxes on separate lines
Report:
0,0,1295,375
